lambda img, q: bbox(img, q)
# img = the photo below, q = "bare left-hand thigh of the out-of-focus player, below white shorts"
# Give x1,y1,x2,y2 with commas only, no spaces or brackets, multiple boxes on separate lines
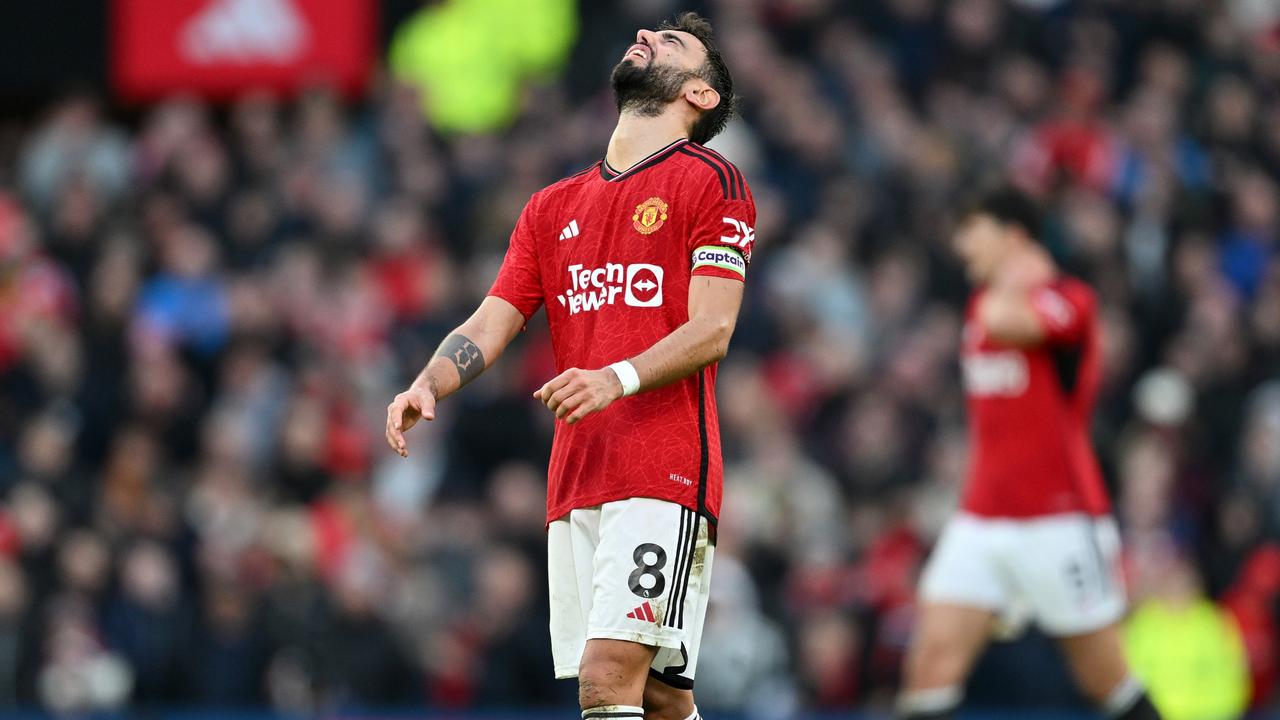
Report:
904,602,996,691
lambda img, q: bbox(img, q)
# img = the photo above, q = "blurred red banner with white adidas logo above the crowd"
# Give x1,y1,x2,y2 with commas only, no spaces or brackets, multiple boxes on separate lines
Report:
111,0,378,100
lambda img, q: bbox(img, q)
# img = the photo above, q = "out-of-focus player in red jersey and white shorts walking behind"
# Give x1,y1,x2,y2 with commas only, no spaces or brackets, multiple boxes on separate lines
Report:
899,188,1158,720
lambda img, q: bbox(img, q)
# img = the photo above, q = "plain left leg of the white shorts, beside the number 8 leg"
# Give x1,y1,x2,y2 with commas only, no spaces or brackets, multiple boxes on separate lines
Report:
547,507,600,679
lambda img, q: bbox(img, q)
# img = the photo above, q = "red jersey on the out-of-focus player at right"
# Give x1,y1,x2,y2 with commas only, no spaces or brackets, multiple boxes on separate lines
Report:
961,278,1110,518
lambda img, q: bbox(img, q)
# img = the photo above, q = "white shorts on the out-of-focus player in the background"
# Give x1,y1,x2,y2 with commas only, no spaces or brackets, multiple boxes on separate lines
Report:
920,512,1125,637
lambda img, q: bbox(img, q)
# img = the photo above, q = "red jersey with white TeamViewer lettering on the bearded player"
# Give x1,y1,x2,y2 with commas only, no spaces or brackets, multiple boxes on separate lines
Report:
489,140,755,521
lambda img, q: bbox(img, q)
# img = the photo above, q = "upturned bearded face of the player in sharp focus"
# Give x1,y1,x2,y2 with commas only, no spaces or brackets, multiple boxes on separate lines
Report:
611,29,707,117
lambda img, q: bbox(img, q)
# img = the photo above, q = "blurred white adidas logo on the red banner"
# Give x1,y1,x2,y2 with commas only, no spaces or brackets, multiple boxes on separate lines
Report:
178,0,308,65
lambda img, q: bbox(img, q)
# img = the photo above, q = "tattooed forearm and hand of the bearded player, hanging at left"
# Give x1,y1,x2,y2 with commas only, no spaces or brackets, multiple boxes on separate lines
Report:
387,296,525,457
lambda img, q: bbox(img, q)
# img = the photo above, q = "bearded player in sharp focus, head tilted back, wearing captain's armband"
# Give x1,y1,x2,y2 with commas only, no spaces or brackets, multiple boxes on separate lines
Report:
387,13,755,720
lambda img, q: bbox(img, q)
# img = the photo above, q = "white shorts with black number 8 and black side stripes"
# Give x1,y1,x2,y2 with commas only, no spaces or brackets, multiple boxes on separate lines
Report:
547,497,714,689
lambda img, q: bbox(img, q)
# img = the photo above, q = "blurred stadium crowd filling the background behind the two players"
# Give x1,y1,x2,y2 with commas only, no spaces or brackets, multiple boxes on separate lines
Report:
0,0,1280,720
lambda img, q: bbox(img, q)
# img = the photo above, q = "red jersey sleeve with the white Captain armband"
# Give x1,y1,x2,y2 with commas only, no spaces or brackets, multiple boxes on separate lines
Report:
689,165,755,281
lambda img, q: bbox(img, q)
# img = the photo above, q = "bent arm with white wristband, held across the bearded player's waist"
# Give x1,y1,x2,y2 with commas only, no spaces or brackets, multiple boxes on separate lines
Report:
534,275,744,424
